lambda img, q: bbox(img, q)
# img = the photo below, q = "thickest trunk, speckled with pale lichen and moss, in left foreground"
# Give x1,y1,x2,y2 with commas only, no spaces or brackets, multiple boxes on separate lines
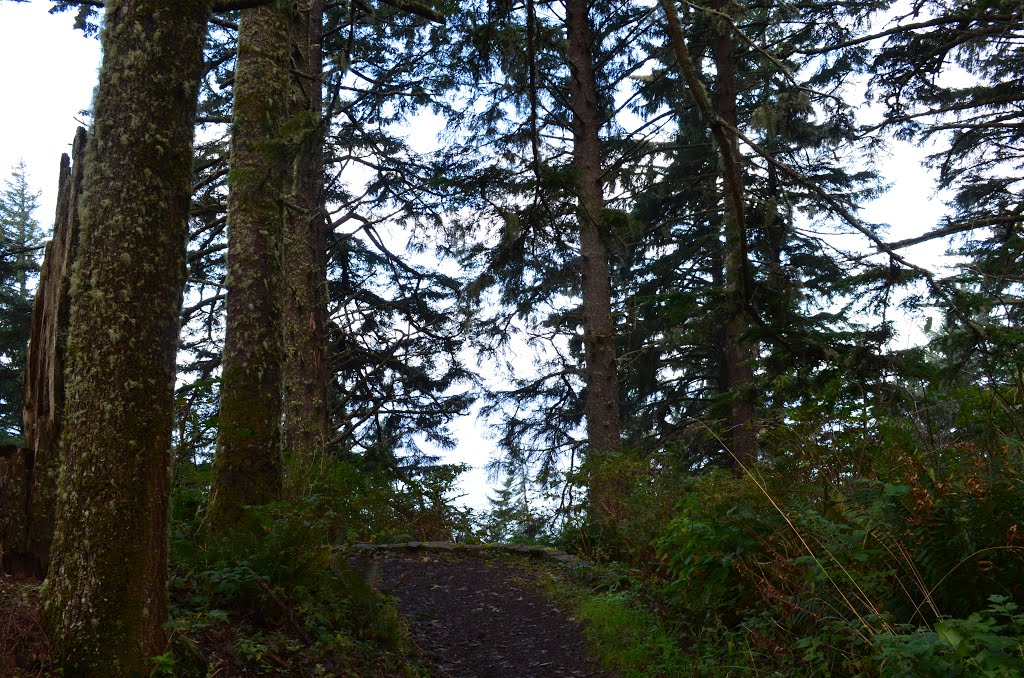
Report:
43,0,211,677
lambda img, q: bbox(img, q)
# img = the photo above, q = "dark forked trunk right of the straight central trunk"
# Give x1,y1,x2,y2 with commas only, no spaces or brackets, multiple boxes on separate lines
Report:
659,0,757,472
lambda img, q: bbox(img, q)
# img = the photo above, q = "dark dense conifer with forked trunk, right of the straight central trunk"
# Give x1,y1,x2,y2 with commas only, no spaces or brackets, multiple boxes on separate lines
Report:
625,2,885,471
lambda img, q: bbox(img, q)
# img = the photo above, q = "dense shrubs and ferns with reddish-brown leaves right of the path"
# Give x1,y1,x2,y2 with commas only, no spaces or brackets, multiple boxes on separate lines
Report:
657,443,1024,675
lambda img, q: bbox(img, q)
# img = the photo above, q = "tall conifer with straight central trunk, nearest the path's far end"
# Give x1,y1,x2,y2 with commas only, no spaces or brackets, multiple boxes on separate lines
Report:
425,2,646,515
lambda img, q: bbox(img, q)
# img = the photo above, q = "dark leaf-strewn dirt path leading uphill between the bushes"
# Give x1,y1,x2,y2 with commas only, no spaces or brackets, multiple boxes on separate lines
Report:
353,553,610,678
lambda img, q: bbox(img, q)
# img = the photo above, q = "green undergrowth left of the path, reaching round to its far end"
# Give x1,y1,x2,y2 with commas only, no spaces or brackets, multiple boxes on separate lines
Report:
164,459,470,676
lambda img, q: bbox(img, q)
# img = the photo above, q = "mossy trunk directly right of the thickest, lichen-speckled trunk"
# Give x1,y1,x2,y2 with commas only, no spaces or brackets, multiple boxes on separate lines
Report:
207,3,292,529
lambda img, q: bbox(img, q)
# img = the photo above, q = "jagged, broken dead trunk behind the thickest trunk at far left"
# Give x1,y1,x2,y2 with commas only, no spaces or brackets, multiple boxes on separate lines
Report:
0,128,86,577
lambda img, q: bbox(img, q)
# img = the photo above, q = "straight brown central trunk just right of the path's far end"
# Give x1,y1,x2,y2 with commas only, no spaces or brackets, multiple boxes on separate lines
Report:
565,0,622,517
